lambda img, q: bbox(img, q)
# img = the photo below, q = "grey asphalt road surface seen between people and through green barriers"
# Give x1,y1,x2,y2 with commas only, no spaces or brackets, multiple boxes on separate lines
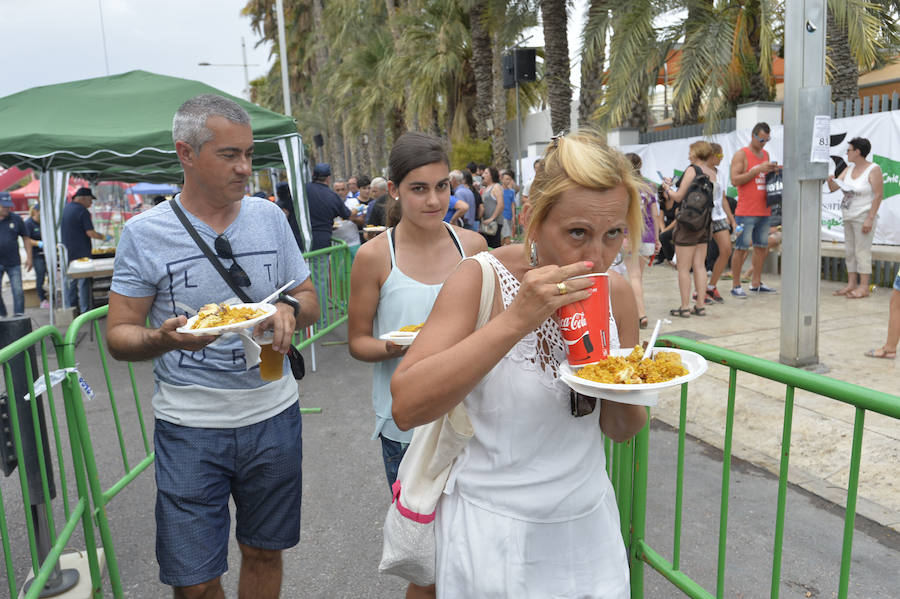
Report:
0,316,900,599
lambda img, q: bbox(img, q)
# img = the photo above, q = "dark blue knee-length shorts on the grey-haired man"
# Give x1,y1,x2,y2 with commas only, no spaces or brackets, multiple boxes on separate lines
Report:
153,404,302,587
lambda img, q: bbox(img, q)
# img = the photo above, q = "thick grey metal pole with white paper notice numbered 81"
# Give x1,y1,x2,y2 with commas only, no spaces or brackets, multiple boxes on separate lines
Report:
780,0,831,366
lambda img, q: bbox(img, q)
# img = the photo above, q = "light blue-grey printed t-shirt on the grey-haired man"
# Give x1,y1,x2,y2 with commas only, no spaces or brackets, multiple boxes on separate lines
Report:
110,196,309,427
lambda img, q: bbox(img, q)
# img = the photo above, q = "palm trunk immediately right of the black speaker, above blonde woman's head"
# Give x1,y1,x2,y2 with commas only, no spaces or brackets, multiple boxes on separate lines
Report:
541,0,572,134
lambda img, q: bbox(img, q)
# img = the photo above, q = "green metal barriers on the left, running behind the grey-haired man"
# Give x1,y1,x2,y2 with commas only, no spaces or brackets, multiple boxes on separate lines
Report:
0,240,351,599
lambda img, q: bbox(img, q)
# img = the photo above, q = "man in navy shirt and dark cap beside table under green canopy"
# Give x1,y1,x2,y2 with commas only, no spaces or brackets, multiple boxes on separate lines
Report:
60,187,112,314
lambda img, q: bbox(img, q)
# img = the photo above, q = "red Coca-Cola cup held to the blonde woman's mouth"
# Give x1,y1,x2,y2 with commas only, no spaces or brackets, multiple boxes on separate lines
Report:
556,273,609,366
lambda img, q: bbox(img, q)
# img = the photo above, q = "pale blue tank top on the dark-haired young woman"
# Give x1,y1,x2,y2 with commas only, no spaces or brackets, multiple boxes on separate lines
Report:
372,225,466,443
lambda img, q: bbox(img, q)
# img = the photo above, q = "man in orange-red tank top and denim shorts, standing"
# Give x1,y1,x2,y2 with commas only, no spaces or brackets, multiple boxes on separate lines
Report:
731,123,778,299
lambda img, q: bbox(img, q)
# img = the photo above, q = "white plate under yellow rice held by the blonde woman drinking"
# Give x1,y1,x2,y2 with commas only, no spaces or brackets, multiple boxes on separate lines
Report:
559,347,709,406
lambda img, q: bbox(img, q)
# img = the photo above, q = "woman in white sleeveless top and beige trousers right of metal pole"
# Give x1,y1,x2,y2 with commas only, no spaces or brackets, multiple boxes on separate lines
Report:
828,137,884,299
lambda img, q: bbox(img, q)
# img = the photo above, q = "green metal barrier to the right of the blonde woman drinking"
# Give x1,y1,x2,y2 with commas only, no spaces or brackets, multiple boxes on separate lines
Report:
624,337,900,599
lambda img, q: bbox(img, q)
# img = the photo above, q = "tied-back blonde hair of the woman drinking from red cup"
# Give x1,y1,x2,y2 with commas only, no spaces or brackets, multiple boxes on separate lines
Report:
525,129,644,253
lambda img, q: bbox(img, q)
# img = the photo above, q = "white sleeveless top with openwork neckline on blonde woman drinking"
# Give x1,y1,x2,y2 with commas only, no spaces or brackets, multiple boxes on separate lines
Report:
445,254,619,522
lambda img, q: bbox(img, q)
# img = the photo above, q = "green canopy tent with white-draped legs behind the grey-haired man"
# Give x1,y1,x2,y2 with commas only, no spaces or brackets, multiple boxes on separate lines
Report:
0,71,312,324
